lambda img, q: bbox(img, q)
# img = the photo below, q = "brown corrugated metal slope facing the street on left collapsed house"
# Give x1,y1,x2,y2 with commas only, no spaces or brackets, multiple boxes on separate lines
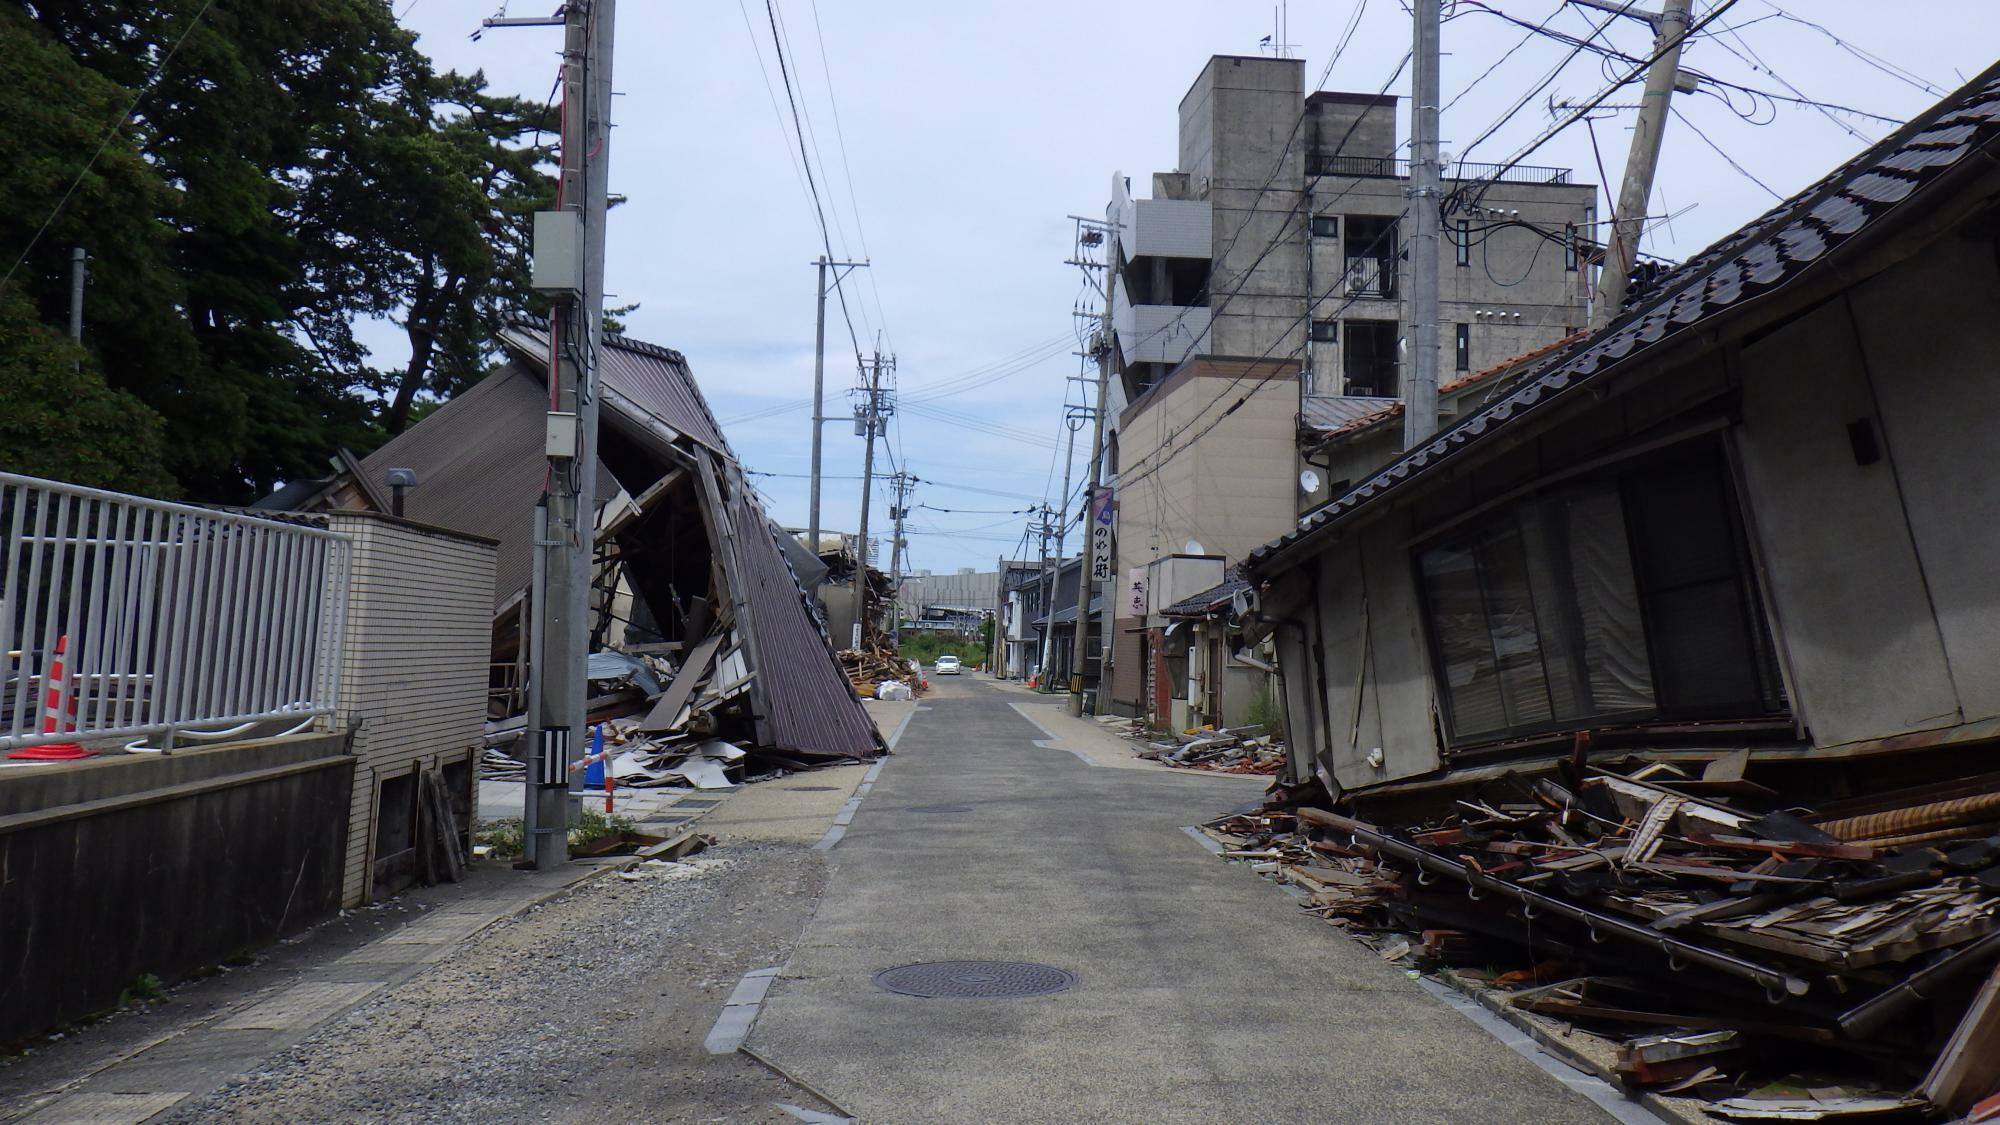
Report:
730,472,878,759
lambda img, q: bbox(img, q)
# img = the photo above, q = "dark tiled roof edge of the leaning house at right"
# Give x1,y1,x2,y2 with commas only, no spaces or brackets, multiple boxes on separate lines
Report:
1248,66,2000,571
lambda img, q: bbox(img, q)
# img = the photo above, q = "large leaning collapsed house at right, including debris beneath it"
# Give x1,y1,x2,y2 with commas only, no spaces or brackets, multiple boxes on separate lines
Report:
1230,66,2000,1119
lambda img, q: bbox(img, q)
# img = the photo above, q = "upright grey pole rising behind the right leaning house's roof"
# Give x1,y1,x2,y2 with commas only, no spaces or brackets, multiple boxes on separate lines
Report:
1402,0,1442,448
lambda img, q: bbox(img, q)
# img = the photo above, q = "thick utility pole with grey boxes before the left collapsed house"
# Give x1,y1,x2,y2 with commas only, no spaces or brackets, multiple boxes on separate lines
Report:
512,0,616,871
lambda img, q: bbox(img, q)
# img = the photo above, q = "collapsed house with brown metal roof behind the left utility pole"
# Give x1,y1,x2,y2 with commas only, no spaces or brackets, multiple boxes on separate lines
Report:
266,320,882,765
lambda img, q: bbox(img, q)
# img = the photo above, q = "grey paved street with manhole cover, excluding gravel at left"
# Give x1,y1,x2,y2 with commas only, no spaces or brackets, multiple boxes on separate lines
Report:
750,677,1606,1123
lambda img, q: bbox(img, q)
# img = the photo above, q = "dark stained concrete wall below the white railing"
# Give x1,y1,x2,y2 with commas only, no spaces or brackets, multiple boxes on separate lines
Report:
0,735,354,1043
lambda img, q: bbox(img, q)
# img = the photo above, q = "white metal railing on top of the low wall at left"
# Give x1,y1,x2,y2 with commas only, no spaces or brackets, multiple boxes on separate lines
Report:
0,472,352,753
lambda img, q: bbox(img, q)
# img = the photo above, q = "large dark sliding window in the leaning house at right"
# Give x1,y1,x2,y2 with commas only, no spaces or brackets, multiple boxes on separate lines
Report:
1416,444,1784,745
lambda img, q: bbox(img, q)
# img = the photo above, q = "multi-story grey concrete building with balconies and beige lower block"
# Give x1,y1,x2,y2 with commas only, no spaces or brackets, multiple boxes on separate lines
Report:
1100,56,1596,713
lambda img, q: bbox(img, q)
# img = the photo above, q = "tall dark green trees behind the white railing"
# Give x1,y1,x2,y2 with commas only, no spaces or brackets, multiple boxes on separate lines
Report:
0,0,554,502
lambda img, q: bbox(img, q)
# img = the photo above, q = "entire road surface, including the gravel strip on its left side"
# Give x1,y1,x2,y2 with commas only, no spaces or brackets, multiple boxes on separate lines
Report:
156,675,1608,1125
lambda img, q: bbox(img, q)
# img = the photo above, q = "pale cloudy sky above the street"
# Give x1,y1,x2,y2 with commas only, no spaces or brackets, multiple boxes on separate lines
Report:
380,0,2000,573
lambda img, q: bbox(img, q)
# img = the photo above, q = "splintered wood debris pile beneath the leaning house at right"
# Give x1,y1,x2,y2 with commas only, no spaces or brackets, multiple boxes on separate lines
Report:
1200,760,2000,1121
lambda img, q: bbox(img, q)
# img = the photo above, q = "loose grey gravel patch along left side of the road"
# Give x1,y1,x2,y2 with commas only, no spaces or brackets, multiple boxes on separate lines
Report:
164,845,824,1123
